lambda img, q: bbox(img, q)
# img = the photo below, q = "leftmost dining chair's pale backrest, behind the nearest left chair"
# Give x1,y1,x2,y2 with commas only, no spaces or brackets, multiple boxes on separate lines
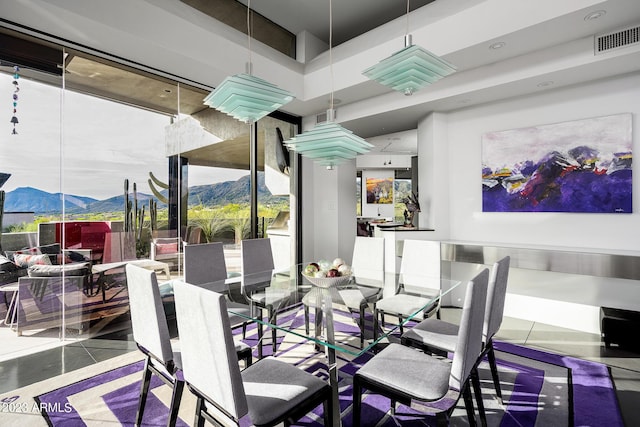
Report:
125,264,173,365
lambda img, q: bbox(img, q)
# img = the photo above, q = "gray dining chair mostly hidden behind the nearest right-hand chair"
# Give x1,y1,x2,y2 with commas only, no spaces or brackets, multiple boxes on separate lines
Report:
401,256,511,401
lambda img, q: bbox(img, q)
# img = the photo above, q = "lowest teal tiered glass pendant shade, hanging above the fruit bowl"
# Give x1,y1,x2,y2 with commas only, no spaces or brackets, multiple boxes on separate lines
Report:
285,110,373,169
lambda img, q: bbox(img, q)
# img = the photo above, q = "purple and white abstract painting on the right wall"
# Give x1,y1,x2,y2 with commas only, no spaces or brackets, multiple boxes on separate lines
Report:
482,113,632,213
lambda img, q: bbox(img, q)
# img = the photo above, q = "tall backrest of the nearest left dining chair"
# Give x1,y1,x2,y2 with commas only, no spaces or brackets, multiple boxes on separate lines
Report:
174,280,248,419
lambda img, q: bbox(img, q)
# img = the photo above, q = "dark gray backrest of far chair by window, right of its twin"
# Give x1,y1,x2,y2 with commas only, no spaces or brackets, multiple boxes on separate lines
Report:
240,239,274,290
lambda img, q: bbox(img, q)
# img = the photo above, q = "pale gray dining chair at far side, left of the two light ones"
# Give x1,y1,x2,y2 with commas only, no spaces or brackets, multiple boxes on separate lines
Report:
303,236,384,347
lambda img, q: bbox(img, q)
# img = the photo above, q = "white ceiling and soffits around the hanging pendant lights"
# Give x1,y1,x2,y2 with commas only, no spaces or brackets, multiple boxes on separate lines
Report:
0,0,640,152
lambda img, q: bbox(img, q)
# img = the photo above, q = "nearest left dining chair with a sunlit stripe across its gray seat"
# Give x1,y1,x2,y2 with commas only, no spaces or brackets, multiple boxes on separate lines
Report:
175,281,333,427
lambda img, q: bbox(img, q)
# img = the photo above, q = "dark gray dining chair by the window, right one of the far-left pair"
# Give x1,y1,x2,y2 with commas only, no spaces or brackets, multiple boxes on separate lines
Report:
240,239,290,358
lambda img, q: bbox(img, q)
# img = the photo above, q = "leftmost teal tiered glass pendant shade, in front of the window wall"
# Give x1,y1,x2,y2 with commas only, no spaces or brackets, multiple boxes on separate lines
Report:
204,73,294,123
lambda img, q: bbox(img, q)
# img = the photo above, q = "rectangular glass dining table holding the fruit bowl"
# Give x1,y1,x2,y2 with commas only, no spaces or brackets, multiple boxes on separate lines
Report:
200,263,461,426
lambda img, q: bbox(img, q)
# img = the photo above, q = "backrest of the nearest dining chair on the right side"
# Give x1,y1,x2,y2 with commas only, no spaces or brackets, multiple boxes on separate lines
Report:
449,268,489,390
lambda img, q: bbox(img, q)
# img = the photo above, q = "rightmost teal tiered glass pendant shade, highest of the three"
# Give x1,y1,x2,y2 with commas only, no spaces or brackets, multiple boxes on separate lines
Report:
362,34,456,95
